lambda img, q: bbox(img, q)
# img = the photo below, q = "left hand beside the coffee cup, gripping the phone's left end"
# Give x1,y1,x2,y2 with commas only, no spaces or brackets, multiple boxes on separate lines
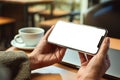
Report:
29,27,66,69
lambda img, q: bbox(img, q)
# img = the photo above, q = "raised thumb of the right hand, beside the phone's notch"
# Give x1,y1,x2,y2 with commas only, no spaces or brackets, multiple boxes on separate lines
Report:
97,37,110,56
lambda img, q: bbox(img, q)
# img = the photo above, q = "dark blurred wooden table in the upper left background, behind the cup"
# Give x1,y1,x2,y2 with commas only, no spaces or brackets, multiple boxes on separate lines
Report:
0,0,54,28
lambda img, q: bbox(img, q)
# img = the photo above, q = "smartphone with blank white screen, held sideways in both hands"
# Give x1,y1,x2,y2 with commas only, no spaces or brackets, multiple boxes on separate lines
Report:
48,21,107,54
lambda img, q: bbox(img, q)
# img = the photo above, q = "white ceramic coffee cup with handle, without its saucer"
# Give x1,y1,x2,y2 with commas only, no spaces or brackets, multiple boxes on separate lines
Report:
14,27,45,47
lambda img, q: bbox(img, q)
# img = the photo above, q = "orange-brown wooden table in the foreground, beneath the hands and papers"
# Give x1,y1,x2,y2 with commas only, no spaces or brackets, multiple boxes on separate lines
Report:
7,38,120,80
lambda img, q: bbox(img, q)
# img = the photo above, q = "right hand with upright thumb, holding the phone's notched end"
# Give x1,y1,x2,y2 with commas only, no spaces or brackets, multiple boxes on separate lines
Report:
78,38,110,80
